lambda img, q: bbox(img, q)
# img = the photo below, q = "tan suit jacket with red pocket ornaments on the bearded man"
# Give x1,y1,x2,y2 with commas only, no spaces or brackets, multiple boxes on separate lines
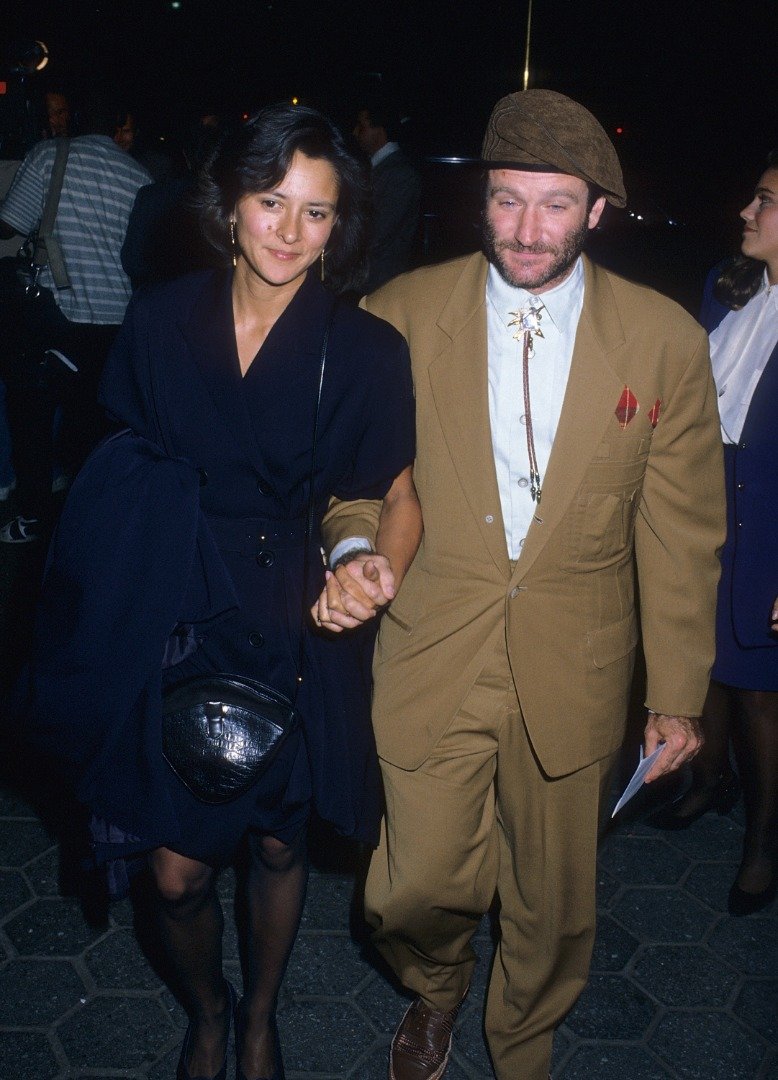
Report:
326,255,725,777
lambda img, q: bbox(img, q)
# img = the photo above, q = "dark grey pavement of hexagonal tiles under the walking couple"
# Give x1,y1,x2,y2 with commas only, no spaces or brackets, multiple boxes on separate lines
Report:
0,512,778,1080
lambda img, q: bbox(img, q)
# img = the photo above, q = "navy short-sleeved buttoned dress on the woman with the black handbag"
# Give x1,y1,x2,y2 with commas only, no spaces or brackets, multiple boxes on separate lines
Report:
31,271,414,865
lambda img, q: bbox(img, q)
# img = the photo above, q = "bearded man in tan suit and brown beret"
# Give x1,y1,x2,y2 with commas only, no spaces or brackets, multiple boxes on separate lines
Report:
319,91,724,1080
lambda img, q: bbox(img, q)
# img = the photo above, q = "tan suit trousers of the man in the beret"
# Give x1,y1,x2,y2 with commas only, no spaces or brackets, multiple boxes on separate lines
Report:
365,635,613,1080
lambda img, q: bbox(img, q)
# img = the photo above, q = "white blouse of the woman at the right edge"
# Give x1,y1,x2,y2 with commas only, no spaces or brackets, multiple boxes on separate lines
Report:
710,270,778,445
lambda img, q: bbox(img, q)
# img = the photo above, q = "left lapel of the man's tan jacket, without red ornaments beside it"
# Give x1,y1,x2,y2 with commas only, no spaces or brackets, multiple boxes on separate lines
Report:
429,255,510,578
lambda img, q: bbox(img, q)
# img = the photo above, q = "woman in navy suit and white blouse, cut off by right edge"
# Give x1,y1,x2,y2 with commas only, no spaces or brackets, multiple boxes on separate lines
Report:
655,154,778,915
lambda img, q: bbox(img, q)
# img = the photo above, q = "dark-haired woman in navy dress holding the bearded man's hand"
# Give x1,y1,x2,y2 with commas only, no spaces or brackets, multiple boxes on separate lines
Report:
49,106,420,1080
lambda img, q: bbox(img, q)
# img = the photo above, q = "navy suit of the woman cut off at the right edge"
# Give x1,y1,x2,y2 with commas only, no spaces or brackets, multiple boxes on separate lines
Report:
702,287,778,691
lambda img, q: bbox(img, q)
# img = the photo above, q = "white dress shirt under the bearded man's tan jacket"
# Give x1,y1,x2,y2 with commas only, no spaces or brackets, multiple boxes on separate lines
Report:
486,258,584,559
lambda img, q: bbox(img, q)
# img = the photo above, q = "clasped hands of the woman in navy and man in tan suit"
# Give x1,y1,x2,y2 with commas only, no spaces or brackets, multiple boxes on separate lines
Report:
311,551,397,634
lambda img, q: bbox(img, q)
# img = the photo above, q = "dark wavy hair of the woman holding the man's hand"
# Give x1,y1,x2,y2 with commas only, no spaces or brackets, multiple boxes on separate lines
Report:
197,105,371,293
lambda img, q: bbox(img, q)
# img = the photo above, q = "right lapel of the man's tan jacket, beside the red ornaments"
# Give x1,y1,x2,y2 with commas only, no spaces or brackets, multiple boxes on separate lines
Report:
514,258,625,580
